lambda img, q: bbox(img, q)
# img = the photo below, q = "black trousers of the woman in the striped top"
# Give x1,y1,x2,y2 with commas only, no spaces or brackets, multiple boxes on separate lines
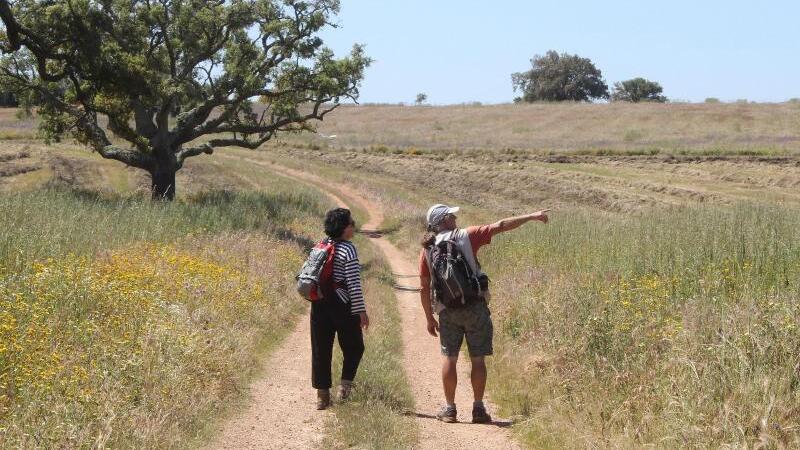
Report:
311,297,364,389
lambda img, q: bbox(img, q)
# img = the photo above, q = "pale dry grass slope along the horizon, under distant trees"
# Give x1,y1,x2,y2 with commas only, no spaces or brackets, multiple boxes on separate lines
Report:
280,103,800,154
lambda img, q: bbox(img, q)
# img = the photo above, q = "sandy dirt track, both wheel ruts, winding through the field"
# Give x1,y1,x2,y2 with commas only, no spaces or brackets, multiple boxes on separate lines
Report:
206,156,517,449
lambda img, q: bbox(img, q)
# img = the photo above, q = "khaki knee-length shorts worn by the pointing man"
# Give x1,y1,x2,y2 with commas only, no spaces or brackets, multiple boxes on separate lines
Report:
439,301,494,358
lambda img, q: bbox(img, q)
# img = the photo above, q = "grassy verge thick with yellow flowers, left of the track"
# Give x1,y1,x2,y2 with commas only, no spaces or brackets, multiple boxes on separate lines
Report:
0,183,327,448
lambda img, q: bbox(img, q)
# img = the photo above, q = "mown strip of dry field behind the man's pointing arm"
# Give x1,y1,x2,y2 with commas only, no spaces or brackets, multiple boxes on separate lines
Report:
260,146,800,212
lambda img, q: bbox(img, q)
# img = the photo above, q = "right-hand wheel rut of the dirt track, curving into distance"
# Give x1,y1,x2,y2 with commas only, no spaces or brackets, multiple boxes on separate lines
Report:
234,159,519,450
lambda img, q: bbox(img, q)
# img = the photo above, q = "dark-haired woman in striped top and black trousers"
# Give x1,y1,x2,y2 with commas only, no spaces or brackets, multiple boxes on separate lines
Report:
311,208,369,409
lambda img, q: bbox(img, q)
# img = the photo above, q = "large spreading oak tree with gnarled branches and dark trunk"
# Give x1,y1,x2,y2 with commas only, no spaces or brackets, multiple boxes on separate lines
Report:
0,0,370,199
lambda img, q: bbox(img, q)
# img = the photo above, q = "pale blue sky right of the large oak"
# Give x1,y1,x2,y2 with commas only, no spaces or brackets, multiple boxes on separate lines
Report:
323,0,800,104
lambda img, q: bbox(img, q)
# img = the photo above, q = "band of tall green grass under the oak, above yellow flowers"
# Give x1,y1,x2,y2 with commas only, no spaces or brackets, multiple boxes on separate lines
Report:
0,187,324,272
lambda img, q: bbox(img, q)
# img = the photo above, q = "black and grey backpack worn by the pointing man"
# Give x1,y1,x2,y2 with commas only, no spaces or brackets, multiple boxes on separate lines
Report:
425,239,484,308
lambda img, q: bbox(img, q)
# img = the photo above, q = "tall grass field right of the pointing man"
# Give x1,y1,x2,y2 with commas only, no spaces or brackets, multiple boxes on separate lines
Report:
482,204,800,448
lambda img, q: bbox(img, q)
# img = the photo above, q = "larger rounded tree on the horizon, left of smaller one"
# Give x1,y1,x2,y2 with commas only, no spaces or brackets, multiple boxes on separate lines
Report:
511,50,608,102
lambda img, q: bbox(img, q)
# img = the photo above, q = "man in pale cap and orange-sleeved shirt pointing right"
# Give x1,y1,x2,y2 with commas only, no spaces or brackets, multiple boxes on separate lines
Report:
419,204,550,423
